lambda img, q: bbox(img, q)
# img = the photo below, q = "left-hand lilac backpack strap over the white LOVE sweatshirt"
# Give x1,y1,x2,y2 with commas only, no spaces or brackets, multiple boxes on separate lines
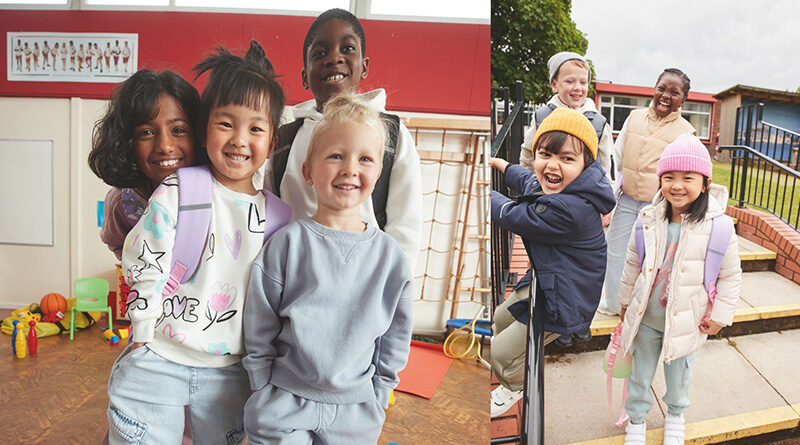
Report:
162,165,213,296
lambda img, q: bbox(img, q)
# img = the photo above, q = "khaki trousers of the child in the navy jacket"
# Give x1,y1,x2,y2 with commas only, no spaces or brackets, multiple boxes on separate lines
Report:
491,286,561,391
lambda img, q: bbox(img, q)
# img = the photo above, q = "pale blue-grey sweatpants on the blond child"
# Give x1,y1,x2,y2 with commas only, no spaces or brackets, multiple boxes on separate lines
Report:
244,385,386,445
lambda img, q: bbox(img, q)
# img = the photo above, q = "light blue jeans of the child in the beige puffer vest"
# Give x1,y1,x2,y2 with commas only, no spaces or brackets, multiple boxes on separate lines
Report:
598,193,650,314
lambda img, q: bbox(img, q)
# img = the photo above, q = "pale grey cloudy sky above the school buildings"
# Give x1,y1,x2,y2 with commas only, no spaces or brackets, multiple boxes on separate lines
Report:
572,0,800,94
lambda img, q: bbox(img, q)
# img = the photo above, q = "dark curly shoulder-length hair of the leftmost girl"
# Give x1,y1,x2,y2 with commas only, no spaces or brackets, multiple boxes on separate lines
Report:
89,70,200,188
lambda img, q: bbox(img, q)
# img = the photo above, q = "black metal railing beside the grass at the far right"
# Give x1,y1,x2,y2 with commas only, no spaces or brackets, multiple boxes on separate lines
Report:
719,103,800,231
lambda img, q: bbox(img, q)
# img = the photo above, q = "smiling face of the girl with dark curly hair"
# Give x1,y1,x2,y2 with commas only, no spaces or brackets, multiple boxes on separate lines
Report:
133,94,195,186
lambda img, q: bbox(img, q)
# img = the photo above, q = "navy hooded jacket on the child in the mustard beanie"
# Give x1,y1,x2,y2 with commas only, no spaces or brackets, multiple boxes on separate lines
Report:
492,161,616,334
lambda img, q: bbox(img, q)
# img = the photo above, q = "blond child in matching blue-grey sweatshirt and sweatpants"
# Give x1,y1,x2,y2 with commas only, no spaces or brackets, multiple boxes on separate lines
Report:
243,96,413,444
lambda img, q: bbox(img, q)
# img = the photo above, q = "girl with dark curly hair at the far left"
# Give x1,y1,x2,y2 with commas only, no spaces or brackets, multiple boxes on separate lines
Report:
89,70,200,259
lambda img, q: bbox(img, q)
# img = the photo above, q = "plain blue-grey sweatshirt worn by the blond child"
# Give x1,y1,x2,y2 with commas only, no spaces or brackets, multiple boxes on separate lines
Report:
242,217,413,407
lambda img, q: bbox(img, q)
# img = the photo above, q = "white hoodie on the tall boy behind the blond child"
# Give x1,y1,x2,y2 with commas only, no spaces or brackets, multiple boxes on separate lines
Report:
266,89,422,272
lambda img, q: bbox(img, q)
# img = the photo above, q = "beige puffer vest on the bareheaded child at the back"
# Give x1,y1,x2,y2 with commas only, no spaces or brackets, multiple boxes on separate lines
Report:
622,101,697,201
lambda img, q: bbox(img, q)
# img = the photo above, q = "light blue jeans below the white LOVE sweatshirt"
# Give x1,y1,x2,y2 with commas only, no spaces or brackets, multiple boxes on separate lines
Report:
107,345,250,445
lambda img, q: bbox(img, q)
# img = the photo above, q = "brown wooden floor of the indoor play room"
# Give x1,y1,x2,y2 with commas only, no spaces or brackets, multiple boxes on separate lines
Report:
0,309,489,445
